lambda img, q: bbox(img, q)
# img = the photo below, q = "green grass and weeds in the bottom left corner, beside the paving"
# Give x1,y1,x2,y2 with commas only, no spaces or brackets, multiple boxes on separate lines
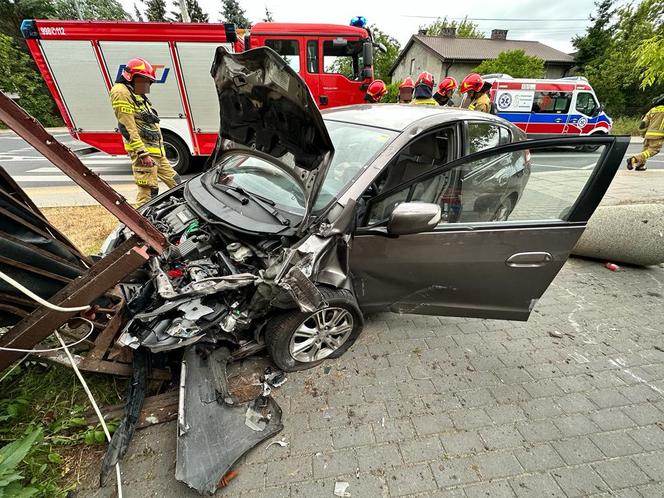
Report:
0,361,126,498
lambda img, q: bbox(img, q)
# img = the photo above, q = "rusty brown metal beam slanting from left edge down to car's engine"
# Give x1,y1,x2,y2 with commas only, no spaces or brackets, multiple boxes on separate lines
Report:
0,92,169,254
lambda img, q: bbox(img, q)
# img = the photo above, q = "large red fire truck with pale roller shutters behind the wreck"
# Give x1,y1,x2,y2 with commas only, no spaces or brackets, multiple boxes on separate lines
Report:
21,20,373,173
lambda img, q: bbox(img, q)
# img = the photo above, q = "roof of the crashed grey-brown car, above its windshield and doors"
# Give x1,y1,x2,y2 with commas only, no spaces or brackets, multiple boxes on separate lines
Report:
321,104,512,132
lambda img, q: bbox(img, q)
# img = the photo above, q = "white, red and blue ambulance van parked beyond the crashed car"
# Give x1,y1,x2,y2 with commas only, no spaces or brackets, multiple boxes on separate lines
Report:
483,74,613,138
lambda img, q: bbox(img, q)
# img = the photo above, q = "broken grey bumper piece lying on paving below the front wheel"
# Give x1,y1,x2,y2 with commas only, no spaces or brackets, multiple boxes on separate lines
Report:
175,346,283,495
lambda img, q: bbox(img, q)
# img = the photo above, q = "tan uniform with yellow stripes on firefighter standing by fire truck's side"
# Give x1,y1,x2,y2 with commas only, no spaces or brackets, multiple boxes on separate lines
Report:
111,83,179,205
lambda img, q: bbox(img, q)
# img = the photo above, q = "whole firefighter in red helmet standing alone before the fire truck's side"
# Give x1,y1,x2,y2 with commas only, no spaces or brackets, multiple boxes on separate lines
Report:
111,58,180,205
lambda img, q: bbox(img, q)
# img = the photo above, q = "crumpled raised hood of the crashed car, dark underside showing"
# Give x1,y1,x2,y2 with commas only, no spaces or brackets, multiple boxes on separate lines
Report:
211,47,334,228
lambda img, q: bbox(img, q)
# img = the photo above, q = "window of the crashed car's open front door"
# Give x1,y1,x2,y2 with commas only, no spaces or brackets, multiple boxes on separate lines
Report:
362,145,606,226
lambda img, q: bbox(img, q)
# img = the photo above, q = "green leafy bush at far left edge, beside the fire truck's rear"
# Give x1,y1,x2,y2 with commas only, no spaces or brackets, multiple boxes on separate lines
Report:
0,34,62,126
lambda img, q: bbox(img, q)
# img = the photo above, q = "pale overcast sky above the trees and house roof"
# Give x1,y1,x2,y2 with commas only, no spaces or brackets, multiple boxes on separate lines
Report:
120,0,622,52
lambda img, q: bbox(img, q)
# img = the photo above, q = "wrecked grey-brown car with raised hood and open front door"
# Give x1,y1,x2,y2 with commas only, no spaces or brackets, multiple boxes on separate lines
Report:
105,48,629,370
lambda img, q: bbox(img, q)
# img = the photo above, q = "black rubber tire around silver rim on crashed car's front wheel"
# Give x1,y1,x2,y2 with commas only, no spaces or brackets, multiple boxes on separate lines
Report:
265,288,364,372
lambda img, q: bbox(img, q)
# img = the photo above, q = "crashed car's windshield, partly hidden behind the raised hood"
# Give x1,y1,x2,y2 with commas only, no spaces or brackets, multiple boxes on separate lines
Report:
215,121,397,214
